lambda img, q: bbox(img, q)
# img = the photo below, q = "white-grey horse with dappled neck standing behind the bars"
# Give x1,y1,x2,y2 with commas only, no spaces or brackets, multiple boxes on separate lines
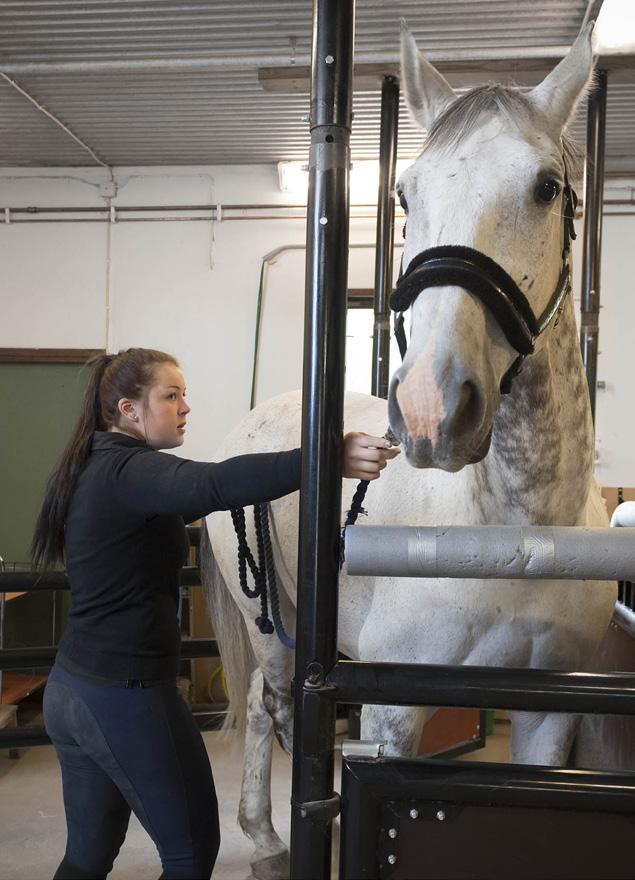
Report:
202,22,616,880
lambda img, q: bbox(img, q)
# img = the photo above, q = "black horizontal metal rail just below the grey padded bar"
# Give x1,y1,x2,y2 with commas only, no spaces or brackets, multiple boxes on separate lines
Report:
320,660,635,715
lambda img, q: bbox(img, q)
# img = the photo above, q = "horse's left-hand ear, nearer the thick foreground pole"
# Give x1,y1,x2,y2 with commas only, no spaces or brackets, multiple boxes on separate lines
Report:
401,18,456,131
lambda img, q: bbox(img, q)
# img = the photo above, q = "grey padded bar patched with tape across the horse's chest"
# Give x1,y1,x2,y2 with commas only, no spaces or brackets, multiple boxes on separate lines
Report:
344,526,635,580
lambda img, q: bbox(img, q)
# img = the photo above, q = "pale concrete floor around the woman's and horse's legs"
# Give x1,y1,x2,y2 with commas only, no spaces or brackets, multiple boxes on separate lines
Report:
0,722,509,880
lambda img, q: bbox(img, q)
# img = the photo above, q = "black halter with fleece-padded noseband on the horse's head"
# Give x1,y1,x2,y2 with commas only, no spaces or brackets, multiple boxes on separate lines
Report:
390,178,578,394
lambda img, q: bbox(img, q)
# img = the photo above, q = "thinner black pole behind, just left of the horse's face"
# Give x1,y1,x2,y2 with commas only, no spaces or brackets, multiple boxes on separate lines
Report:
371,76,399,397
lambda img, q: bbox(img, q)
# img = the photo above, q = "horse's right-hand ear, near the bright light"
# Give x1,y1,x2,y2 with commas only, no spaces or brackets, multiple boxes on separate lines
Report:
528,21,594,135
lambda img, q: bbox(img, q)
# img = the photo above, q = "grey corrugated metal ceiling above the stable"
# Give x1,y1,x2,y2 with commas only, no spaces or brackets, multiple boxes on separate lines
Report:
0,0,635,172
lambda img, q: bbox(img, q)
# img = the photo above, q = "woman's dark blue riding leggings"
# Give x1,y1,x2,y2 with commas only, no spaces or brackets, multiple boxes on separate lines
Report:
44,665,220,880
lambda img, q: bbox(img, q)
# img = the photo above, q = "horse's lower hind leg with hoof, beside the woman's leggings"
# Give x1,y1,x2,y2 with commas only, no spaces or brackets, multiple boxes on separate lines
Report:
238,668,289,880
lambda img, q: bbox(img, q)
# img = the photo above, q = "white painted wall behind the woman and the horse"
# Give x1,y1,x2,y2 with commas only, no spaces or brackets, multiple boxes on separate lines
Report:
0,166,635,486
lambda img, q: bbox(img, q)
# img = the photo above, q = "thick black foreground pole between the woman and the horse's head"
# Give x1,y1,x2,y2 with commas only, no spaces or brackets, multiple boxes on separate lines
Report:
291,0,355,880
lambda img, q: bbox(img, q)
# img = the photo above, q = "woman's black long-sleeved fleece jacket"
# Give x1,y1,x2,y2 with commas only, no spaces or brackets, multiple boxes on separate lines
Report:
58,431,300,682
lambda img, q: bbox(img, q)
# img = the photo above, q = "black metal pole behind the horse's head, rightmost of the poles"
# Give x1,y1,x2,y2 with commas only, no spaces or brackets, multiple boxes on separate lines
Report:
580,70,607,422
